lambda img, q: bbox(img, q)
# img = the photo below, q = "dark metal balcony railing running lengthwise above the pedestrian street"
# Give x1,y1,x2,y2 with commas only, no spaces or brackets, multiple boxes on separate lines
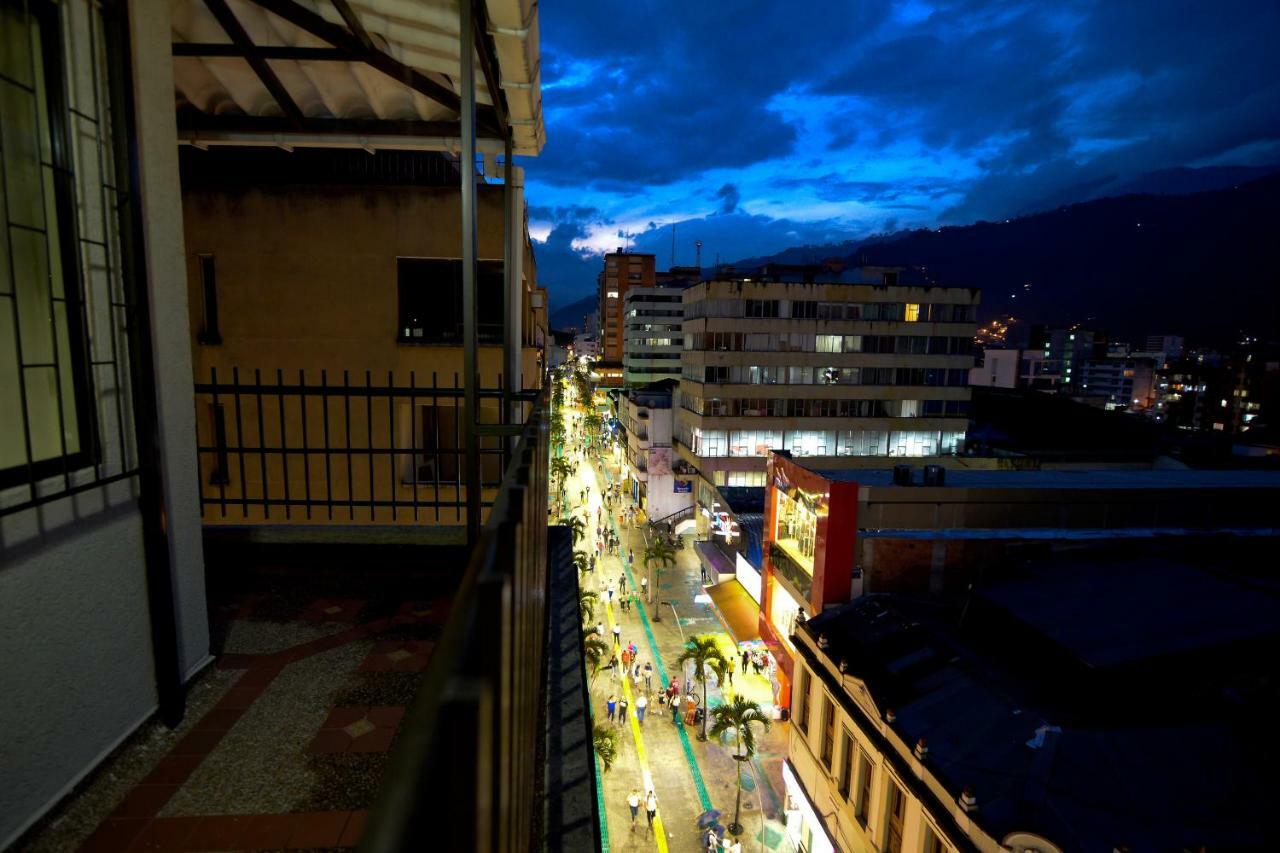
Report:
360,391,600,853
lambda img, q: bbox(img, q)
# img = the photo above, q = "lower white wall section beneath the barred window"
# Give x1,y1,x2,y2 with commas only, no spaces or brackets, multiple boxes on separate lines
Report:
0,482,156,848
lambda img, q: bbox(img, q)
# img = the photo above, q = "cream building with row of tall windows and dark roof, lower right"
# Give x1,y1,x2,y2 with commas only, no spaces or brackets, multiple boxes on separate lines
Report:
783,555,1280,853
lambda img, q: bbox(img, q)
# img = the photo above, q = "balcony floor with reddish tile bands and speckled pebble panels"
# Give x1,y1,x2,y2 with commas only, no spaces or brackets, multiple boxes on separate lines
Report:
27,540,461,853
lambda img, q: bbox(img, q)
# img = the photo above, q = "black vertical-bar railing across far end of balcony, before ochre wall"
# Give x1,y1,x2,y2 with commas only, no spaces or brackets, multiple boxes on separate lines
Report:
195,369,536,524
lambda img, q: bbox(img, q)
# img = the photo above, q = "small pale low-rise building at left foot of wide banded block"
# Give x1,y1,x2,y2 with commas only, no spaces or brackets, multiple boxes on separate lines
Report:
622,379,694,521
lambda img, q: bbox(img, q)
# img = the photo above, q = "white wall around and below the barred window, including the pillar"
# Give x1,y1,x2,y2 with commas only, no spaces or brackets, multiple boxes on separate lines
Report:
0,0,209,848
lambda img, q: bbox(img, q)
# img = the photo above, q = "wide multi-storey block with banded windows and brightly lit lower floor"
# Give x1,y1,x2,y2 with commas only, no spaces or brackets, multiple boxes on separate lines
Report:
677,266,979,485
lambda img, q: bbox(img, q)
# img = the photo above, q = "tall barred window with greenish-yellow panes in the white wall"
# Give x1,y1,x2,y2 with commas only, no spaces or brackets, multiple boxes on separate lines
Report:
0,0,93,485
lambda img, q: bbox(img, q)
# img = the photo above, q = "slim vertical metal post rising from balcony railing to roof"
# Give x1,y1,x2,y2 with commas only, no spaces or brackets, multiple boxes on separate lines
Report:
458,0,481,544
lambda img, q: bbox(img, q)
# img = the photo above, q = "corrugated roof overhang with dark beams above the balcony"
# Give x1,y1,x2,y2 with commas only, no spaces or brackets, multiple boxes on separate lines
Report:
170,0,545,156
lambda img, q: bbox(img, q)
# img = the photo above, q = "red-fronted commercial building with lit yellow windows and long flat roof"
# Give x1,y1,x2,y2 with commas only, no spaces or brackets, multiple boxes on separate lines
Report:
759,452,1280,712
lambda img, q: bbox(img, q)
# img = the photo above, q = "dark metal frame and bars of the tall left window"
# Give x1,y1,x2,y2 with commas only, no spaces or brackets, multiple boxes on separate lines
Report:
0,0,101,489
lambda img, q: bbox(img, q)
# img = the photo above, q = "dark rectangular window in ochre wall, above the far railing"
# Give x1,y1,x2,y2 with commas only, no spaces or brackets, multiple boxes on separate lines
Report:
397,257,501,343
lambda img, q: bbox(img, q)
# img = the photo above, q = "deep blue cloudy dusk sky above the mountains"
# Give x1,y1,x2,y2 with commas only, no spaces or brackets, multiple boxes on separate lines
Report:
525,0,1280,307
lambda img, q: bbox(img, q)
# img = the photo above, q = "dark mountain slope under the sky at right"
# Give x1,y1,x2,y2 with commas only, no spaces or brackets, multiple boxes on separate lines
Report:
735,169,1280,343
